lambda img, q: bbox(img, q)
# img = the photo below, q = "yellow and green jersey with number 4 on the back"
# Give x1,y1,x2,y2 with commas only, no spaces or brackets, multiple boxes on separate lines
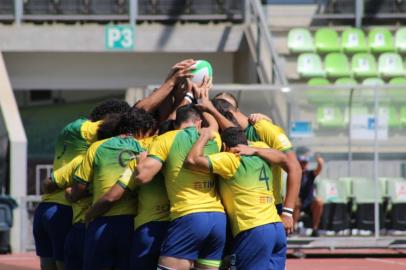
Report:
207,143,281,236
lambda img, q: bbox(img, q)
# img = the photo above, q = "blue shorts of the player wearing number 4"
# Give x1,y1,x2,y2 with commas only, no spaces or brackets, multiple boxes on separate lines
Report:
231,222,286,270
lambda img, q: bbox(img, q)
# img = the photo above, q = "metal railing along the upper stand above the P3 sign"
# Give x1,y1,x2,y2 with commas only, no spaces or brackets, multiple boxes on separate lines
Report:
6,0,243,24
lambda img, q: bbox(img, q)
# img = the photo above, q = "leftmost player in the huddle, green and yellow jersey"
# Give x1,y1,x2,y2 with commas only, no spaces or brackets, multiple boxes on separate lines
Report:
33,99,129,270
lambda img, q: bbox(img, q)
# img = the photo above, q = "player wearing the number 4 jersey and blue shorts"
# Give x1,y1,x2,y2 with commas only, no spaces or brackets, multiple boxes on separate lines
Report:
186,127,288,270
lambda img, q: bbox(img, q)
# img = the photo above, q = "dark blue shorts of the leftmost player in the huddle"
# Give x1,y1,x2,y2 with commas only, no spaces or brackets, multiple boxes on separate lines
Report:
33,202,72,261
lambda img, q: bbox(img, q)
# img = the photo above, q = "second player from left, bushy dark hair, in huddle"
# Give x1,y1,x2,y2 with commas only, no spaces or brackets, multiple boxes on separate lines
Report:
71,108,153,270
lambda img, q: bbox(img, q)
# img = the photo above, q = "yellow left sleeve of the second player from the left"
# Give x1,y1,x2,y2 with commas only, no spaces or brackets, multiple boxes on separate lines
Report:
73,141,103,185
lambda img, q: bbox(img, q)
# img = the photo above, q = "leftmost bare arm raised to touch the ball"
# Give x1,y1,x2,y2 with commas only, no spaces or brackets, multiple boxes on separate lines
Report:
134,59,196,112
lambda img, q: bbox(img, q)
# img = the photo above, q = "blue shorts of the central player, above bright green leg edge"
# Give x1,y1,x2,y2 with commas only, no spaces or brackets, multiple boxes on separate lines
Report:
161,212,227,261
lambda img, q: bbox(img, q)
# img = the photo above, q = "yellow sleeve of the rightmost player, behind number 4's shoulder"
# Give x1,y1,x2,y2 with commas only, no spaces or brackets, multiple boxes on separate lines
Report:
254,119,292,152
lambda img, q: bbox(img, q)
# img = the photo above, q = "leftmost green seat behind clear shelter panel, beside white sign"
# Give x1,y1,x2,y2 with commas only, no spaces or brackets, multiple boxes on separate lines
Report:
317,106,346,128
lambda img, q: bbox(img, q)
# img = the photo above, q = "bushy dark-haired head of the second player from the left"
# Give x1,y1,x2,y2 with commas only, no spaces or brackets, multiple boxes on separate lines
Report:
118,107,157,139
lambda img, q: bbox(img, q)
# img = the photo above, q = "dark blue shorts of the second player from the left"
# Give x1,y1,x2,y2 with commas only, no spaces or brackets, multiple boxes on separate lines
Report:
83,215,134,270
